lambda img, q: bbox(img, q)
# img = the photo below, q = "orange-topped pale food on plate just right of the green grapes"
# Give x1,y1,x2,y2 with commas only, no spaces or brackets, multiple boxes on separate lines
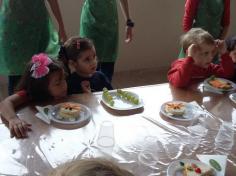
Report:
165,102,186,115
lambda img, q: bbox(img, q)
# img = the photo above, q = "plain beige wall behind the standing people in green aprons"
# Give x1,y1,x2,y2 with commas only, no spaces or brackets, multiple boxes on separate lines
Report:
53,0,236,71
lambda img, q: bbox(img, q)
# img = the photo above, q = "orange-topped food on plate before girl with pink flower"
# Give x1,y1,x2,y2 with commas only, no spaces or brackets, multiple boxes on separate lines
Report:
59,103,81,119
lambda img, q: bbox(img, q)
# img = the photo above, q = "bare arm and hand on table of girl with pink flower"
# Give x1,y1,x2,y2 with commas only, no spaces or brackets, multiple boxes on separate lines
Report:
0,94,31,138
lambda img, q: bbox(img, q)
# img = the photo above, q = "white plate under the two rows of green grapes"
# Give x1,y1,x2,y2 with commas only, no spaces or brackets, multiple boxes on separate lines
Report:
101,90,143,110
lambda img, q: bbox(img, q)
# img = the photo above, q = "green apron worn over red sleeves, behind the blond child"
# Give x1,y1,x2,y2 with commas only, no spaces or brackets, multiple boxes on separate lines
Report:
179,0,224,58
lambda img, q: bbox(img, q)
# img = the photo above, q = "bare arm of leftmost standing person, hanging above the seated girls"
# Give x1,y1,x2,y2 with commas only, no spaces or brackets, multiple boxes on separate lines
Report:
48,0,67,42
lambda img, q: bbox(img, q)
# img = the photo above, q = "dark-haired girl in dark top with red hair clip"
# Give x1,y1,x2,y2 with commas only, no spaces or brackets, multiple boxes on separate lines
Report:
59,37,112,94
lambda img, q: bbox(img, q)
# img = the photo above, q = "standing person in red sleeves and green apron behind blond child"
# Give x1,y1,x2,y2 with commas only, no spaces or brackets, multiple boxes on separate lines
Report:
179,0,230,58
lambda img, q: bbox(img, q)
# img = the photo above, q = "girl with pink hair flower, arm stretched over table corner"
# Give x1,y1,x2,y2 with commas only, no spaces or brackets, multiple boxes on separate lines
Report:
0,53,67,138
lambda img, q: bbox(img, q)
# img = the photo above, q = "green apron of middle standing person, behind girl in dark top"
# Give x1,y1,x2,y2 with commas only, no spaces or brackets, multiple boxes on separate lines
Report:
80,0,119,62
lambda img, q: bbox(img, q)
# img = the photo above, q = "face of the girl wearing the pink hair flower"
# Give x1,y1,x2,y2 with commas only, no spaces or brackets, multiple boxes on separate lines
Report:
48,71,67,99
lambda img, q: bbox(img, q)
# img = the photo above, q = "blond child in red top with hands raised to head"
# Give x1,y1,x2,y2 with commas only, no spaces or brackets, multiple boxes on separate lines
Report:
168,28,234,87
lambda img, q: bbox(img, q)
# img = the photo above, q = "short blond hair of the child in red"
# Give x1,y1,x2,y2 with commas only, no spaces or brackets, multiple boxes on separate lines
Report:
180,28,215,53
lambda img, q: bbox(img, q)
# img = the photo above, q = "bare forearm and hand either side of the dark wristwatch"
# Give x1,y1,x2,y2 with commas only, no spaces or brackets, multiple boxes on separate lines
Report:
120,0,133,43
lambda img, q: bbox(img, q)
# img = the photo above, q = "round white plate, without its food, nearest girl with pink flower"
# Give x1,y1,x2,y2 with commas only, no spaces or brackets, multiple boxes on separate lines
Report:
50,102,92,125
